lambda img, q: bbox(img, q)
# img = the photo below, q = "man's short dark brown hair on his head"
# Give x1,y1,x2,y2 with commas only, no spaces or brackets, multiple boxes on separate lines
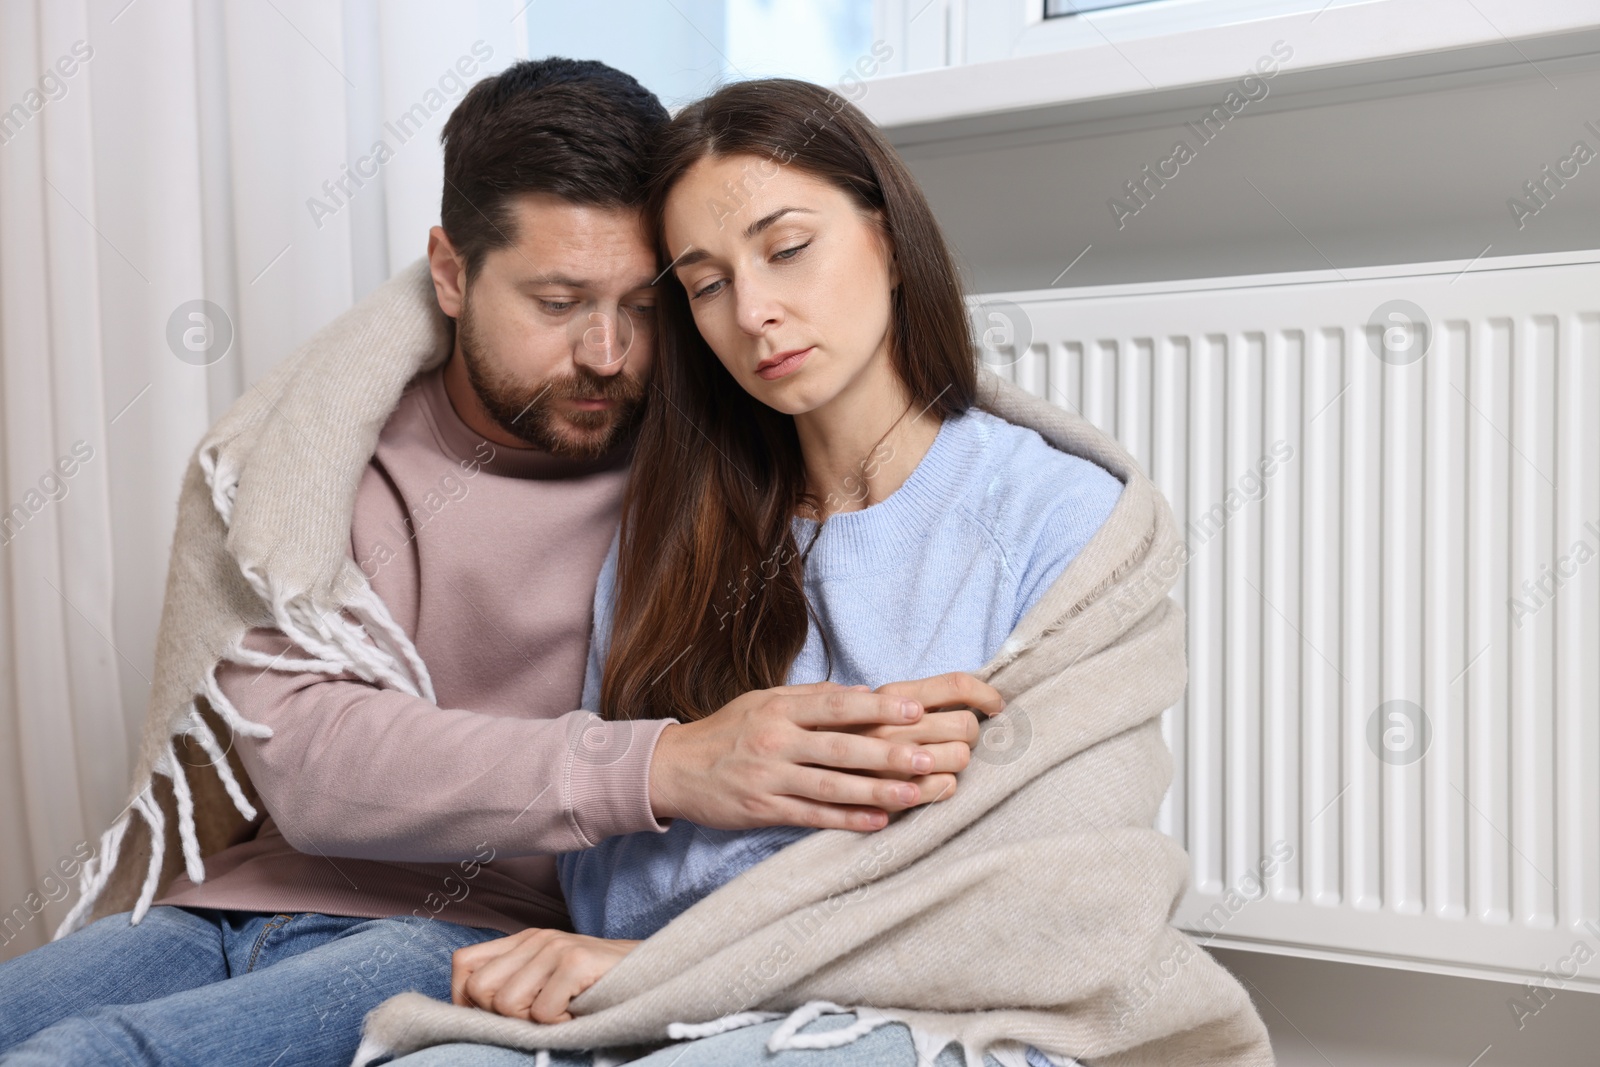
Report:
440,56,669,278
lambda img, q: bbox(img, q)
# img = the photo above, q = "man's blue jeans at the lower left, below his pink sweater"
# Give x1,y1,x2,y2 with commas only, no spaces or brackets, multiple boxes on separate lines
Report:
0,907,502,1067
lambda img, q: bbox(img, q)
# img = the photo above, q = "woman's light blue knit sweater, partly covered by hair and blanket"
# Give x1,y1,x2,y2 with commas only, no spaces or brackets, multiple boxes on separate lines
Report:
557,408,1122,939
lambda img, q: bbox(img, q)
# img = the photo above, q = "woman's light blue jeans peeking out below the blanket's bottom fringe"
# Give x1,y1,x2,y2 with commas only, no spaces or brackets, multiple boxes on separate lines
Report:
390,1014,1030,1067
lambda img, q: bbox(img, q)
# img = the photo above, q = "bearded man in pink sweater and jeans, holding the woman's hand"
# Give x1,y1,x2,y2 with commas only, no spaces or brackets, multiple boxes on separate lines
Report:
0,59,998,1067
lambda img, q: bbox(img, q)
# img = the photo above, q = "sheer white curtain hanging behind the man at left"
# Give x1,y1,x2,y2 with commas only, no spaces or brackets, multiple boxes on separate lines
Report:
0,0,547,958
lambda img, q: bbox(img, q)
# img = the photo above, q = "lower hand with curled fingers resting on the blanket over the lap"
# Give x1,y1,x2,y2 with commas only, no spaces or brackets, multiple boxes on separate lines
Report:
450,928,640,1024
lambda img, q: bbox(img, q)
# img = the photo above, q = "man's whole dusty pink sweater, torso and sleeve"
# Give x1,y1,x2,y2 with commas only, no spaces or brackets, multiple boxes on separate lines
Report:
157,368,670,933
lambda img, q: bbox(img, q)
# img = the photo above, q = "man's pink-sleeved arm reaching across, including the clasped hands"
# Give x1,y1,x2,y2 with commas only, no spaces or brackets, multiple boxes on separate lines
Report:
218,630,1000,862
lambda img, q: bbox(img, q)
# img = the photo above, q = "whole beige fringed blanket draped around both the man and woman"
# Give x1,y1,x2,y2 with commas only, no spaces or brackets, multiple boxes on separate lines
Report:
58,254,1272,1067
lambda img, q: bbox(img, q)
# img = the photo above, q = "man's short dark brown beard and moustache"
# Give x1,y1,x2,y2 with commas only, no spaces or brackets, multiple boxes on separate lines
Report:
456,299,645,459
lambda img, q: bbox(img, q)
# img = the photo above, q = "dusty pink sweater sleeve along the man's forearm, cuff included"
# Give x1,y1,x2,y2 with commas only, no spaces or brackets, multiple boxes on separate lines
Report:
216,630,670,862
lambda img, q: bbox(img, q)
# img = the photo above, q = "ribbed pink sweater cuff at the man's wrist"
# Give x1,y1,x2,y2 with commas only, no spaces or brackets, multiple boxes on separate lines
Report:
566,715,678,848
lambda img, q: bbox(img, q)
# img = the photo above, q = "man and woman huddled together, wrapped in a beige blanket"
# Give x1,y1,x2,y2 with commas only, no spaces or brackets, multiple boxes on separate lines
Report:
0,59,1270,1067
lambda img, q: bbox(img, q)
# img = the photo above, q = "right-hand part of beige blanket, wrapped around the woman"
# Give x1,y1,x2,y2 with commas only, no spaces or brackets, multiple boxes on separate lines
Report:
347,303,1274,1067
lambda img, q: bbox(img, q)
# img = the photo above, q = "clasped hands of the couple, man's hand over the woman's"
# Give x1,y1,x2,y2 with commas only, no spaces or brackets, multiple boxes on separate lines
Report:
650,672,1005,830
